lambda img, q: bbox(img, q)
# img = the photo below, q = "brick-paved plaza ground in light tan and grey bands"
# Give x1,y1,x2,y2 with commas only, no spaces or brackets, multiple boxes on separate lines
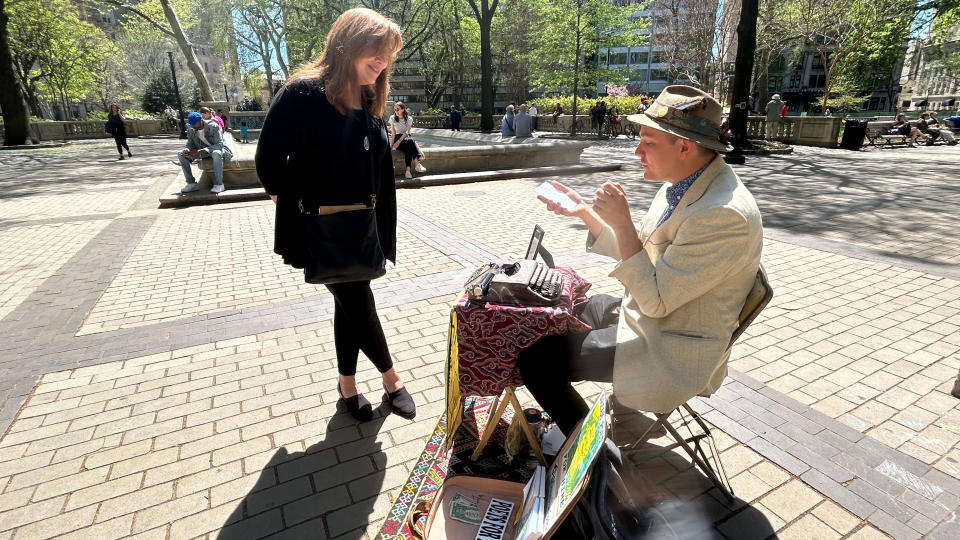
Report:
0,140,960,539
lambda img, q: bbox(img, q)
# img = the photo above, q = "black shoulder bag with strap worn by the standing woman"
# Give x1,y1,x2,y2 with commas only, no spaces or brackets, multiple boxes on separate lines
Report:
297,112,387,284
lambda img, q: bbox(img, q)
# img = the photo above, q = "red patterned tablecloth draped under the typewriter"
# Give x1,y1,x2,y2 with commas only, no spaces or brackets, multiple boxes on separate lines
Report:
454,267,591,396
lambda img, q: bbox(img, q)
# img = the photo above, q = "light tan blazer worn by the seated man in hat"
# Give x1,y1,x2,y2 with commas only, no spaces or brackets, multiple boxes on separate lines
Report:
587,156,763,412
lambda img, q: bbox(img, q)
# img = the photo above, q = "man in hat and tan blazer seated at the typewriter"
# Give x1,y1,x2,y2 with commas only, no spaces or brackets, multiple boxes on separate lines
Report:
518,85,763,434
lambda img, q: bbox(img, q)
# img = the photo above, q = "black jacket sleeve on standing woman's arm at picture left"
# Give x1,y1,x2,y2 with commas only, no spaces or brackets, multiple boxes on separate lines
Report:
254,87,302,195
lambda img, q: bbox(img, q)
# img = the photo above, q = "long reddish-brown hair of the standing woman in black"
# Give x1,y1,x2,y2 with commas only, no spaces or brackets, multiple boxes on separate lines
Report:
290,8,403,118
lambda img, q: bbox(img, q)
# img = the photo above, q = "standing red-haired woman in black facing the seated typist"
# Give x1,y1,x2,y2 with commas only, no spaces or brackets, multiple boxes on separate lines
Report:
256,8,416,422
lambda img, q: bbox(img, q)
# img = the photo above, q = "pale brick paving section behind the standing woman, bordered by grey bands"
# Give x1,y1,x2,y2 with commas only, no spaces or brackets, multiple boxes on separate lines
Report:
77,209,463,335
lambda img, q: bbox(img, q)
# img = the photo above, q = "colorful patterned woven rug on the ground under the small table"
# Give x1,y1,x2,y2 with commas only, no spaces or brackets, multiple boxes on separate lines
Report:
376,398,537,540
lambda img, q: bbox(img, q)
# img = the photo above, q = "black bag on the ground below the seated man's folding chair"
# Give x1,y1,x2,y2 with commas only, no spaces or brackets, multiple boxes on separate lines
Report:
553,438,678,540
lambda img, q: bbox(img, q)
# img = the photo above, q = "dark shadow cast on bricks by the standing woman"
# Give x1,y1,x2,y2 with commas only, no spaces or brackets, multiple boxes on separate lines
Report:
216,402,390,540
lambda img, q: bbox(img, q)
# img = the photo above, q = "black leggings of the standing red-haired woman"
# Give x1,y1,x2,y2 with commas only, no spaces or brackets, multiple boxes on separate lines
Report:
326,281,393,377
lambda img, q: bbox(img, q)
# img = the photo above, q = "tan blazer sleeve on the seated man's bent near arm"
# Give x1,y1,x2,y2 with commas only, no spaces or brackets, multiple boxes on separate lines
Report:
610,207,750,318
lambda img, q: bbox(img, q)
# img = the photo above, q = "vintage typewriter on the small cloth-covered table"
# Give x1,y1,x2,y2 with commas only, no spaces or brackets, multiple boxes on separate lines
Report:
464,225,563,306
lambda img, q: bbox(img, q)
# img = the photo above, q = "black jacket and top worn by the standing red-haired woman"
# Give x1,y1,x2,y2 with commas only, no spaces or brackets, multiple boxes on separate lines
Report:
256,79,397,268
